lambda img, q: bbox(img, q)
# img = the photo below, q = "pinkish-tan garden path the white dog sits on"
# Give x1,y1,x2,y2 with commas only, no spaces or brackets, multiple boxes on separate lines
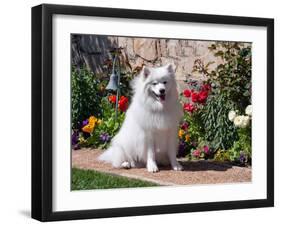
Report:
72,148,252,185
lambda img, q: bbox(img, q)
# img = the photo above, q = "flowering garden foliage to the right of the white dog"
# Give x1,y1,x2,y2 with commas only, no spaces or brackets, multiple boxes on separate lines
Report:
179,42,251,164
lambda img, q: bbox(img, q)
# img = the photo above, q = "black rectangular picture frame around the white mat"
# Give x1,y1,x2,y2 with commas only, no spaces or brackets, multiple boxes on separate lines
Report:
32,4,274,221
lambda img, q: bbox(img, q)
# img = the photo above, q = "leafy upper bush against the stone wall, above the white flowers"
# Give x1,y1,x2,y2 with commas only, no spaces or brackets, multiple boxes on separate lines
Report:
207,42,252,110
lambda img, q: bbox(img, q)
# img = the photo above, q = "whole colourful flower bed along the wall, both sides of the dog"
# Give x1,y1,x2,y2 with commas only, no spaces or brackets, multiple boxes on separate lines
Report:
72,42,252,165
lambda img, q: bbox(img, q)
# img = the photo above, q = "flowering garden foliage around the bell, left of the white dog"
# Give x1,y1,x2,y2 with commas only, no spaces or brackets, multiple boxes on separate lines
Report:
71,52,132,149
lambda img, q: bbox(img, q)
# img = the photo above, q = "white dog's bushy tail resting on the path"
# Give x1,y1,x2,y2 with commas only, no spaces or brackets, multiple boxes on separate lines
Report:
98,146,124,168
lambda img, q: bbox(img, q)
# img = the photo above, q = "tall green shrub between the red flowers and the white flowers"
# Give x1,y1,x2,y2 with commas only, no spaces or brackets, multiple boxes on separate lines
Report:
193,42,252,158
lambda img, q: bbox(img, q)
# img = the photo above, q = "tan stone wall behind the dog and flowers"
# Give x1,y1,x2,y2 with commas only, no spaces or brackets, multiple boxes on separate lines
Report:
72,35,220,80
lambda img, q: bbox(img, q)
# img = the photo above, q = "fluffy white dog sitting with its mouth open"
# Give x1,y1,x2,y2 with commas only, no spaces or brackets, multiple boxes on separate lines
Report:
99,64,183,172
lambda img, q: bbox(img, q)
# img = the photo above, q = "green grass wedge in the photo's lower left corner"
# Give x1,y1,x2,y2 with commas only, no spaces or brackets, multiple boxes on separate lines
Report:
71,168,159,190
